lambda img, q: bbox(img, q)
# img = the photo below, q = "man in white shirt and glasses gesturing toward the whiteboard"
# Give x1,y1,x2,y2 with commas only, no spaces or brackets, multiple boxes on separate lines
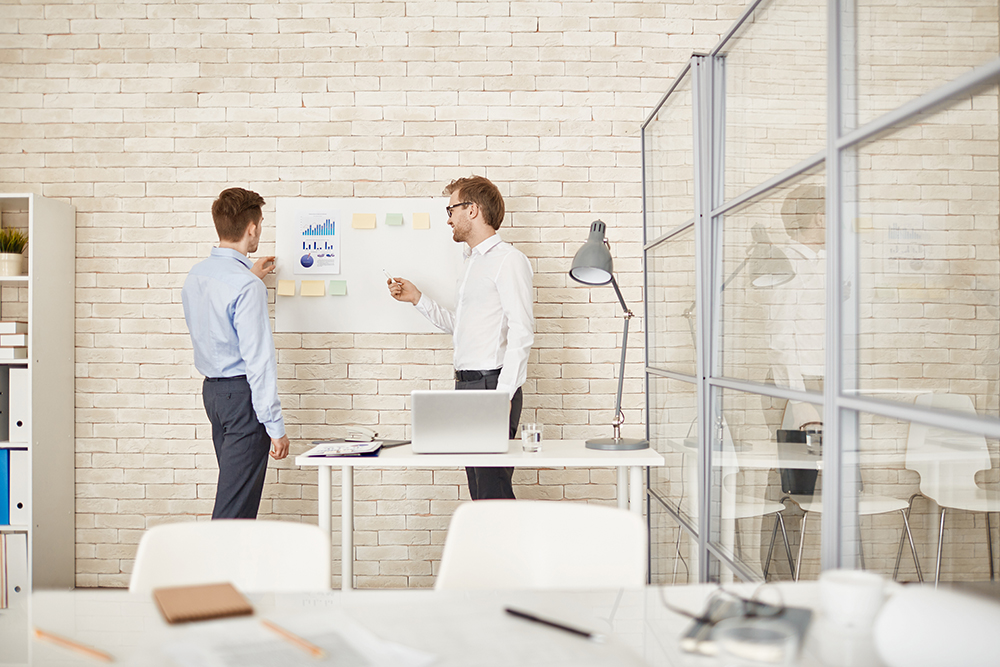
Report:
388,176,535,500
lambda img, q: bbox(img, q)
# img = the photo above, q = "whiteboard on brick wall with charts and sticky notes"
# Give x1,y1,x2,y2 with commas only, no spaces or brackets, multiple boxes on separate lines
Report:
274,197,465,333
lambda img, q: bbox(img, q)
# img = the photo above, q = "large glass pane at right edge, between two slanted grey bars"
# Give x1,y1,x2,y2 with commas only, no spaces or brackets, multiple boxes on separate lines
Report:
856,86,1000,416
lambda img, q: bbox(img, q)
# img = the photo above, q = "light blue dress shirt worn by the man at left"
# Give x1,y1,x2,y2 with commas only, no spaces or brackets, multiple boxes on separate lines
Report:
181,248,285,438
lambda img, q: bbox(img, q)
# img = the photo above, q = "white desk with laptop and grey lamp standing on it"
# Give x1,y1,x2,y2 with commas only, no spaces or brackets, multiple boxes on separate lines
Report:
295,440,663,589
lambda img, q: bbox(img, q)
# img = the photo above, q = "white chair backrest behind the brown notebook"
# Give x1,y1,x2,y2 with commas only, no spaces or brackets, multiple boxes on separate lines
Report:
129,519,330,593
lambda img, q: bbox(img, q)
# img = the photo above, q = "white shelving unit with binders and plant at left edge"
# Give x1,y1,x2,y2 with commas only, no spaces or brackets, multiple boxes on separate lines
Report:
0,193,76,664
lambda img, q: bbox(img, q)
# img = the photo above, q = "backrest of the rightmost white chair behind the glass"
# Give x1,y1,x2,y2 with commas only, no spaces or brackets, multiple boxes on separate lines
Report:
906,394,991,501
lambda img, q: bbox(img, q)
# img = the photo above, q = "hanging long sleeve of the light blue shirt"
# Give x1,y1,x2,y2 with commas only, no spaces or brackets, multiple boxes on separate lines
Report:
233,280,285,438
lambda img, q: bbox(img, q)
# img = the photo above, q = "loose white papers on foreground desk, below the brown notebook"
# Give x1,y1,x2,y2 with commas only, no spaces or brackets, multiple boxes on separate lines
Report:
164,612,436,667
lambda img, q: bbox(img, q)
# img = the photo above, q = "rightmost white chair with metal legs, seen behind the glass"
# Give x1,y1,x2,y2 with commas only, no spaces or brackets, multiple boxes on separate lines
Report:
896,394,1000,586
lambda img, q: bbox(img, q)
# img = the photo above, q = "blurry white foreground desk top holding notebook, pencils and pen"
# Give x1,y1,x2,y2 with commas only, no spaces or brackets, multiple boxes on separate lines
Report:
21,582,879,667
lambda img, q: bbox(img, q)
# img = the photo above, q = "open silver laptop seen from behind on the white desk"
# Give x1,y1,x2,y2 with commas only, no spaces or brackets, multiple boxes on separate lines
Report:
410,389,510,454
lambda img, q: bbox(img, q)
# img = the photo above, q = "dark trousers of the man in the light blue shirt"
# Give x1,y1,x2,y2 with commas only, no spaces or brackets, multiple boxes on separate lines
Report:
201,375,271,519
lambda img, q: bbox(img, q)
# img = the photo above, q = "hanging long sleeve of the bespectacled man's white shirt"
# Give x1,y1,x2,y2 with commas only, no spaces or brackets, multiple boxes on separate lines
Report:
496,253,535,398
